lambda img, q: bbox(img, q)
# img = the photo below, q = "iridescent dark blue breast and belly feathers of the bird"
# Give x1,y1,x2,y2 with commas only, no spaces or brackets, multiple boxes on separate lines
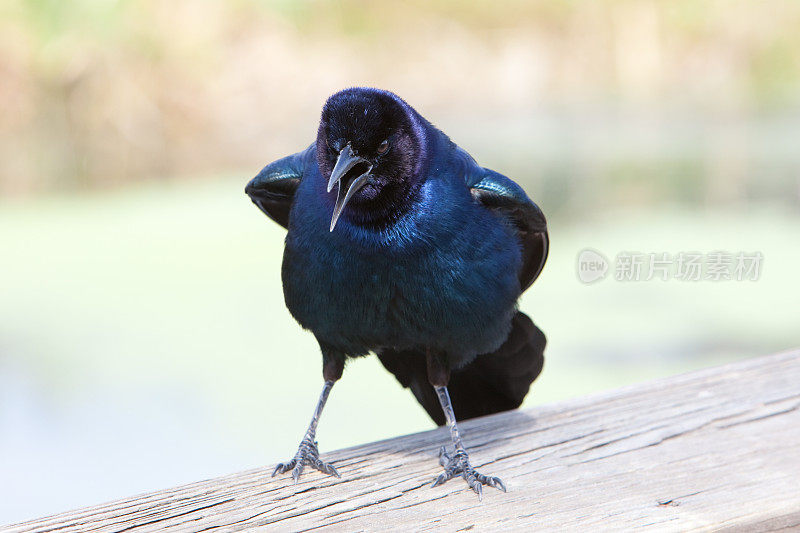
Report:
283,175,520,356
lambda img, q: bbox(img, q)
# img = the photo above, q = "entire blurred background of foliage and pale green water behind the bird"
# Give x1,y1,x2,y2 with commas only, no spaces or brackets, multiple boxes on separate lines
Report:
0,0,800,523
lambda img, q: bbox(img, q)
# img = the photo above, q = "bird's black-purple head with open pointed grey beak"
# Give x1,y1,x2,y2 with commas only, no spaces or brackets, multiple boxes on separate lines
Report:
317,87,425,231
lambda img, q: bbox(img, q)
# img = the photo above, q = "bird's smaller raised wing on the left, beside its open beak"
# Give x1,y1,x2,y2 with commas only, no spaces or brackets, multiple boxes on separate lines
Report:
245,144,316,228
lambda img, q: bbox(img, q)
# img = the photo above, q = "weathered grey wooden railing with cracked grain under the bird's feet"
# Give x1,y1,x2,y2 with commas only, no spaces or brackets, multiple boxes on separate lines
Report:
0,352,800,532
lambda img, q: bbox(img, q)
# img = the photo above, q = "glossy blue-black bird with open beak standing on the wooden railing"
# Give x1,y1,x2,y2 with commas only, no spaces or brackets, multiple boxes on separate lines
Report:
246,88,548,496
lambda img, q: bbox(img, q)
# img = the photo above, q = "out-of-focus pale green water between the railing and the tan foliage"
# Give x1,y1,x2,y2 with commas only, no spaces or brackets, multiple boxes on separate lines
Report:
0,180,800,523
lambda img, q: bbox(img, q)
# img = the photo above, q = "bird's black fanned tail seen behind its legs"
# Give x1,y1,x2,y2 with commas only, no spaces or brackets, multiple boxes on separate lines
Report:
378,311,547,426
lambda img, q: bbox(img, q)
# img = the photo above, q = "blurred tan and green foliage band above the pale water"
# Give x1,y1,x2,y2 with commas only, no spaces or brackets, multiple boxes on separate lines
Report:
0,0,800,211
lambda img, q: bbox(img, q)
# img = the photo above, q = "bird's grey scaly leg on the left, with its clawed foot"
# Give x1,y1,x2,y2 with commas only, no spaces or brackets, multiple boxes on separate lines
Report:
272,350,344,483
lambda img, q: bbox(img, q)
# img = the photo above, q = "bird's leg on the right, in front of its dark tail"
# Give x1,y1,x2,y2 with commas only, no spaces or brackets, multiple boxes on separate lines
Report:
427,351,506,499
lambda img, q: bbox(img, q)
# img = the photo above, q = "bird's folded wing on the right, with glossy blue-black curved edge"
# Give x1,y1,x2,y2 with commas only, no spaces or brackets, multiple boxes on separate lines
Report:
458,148,550,291
